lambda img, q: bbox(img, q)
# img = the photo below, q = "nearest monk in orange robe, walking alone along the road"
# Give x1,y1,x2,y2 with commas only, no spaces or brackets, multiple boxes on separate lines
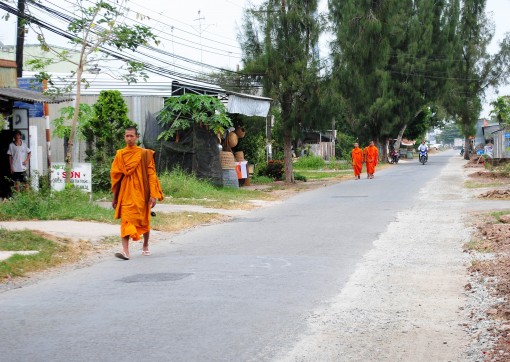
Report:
110,127,163,260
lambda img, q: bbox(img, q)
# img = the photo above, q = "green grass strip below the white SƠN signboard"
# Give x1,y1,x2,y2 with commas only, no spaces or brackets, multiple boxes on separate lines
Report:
0,188,113,223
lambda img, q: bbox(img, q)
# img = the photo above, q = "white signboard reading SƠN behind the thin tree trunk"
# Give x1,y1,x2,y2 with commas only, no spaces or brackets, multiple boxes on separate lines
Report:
51,162,92,192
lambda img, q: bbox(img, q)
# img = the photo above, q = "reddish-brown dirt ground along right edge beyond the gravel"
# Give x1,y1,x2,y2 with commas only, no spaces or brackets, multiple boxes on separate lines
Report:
465,160,510,362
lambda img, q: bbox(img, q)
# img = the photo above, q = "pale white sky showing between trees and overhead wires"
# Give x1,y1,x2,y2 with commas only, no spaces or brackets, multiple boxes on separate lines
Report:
0,0,510,117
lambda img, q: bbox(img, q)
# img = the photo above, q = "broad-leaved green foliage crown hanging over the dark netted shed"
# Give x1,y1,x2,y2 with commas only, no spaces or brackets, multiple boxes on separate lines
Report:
158,93,232,141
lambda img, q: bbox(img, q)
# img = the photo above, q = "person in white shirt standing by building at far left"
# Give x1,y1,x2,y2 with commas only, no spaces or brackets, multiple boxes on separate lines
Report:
7,130,31,192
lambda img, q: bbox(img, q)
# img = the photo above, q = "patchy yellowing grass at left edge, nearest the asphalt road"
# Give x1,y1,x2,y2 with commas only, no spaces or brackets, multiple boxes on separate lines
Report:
0,229,86,280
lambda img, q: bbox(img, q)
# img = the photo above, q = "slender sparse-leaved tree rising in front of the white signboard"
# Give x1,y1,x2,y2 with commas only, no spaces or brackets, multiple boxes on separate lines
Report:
22,0,158,182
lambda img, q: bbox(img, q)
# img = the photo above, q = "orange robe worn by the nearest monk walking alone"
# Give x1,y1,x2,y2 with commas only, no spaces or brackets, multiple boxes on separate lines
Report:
110,146,163,241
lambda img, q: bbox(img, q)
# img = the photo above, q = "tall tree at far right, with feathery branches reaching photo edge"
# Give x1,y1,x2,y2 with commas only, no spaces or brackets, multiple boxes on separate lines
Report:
444,0,510,160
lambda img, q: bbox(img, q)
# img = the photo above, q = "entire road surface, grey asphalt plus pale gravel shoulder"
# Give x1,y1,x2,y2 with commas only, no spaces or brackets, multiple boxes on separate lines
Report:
0,151,478,362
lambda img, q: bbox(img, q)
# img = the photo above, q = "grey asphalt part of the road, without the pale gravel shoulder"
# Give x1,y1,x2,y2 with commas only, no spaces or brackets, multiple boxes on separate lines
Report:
0,152,466,361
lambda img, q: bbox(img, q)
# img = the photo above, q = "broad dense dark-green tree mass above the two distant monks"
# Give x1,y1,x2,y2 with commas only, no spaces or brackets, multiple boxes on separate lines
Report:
329,0,449,159
